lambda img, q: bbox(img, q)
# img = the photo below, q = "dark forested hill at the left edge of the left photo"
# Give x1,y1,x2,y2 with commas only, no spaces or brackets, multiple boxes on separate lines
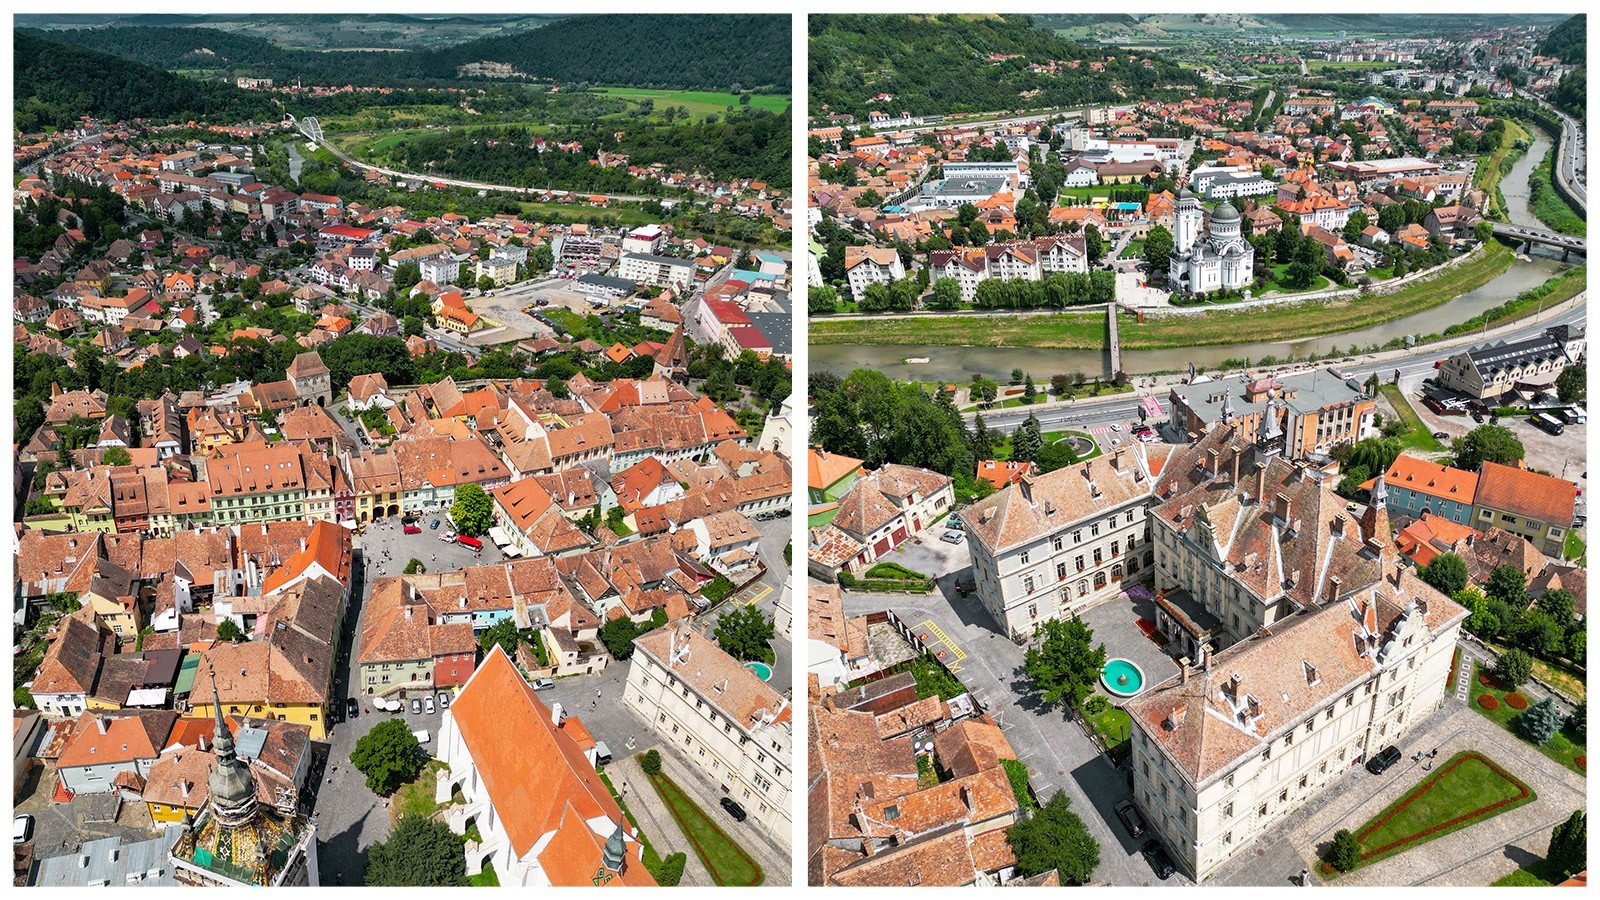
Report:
13,32,282,131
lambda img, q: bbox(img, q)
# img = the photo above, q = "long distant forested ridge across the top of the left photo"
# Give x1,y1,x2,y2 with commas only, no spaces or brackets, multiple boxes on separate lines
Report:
34,14,790,91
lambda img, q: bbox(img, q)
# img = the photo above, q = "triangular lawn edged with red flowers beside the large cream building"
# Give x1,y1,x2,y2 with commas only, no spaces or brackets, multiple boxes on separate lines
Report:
1322,751,1538,876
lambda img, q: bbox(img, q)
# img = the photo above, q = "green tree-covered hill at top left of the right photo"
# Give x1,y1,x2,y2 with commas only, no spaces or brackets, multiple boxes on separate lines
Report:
810,14,1198,117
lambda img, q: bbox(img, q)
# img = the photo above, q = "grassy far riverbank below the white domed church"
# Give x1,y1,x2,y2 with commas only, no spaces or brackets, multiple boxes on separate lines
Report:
810,242,1515,351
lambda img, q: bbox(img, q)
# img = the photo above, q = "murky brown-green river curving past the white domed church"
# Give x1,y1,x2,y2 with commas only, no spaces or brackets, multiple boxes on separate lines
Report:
811,130,1563,381
